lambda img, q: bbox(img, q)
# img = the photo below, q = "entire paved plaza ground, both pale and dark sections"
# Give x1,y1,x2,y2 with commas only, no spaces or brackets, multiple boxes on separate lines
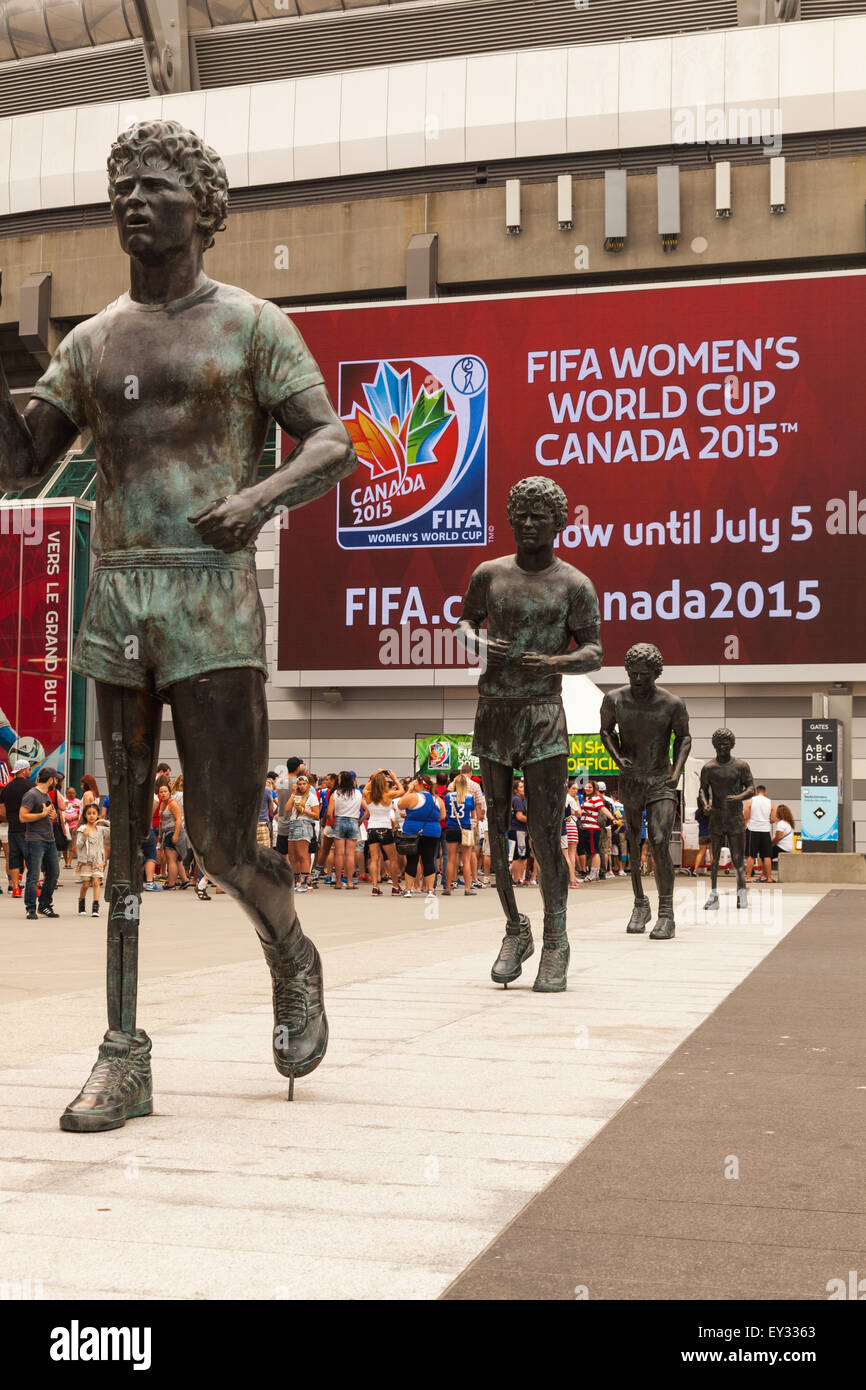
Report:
0,873,866,1300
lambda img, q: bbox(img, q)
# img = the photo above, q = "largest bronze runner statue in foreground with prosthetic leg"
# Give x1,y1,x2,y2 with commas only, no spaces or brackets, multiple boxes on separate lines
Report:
0,113,357,1131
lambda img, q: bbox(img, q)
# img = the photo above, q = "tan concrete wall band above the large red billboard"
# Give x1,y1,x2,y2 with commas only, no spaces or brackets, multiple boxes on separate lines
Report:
0,156,866,322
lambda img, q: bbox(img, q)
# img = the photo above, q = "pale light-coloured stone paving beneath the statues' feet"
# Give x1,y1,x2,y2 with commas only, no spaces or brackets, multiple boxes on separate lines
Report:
0,883,820,1298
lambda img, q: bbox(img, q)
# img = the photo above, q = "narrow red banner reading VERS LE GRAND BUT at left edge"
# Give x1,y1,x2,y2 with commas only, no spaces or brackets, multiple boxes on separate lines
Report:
0,503,72,770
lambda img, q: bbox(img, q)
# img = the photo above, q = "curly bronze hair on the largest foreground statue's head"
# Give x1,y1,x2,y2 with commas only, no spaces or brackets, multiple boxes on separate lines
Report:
108,121,228,250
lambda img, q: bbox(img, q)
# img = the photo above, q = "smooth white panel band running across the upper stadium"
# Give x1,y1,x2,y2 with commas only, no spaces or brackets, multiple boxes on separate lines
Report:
0,15,866,215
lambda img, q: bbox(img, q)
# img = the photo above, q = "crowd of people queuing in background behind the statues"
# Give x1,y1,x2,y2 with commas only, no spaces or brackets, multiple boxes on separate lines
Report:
0,758,794,920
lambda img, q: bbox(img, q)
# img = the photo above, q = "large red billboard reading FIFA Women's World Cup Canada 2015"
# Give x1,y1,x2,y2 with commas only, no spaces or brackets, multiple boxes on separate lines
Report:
278,274,866,671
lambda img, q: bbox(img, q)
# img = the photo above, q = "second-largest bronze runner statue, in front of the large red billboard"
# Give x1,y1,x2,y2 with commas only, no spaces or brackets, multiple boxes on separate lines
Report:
457,478,602,994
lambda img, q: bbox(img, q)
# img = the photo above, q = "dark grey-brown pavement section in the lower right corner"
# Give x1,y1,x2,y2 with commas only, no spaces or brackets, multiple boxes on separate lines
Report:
445,894,866,1300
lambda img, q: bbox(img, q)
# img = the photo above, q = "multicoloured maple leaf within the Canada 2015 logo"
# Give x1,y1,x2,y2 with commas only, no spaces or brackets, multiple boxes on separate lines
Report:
345,361,455,487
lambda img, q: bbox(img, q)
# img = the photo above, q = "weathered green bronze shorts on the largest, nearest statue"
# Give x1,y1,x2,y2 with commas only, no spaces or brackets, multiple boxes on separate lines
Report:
72,548,268,698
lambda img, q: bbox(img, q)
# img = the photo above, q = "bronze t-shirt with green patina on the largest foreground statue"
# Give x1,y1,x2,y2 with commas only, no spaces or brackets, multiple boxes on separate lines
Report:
33,279,322,553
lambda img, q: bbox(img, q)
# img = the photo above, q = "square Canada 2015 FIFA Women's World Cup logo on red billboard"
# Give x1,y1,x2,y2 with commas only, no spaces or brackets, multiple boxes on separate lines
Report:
336,354,488,549
